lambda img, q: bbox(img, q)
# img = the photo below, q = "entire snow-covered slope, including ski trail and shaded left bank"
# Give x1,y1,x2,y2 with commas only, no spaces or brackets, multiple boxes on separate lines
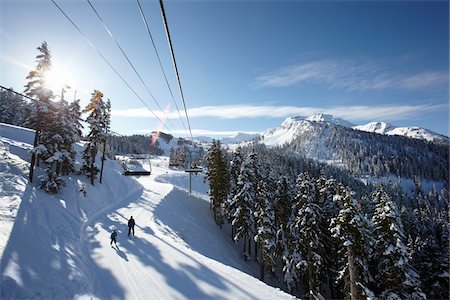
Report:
0,124,292,299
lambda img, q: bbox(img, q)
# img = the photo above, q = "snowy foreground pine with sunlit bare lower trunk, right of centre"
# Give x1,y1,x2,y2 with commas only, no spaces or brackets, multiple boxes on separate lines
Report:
330,190,374,300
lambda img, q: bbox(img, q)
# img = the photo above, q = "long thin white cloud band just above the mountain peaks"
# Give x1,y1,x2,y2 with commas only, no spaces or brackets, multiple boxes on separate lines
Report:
112,103,449,121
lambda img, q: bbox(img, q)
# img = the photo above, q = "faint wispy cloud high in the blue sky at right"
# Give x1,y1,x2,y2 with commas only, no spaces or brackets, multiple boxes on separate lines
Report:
256,59,449,91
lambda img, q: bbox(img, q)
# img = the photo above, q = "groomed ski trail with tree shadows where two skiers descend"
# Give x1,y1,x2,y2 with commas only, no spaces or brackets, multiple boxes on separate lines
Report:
79,158,292,299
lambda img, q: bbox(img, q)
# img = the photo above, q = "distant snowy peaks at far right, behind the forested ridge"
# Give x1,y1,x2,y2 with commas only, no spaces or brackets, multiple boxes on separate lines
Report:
353,122,448,142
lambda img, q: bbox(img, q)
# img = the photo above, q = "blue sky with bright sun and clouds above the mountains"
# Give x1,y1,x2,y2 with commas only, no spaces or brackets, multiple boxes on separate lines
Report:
0,0,449,136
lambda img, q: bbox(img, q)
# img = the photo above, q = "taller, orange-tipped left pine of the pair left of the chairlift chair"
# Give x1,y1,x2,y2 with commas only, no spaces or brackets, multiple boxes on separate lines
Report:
80,90,107,185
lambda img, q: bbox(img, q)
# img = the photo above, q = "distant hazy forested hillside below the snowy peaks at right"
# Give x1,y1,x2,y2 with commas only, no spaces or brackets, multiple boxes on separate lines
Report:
290,122,449,183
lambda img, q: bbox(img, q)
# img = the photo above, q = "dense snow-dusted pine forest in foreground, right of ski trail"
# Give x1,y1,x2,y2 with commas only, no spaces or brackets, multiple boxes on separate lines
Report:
206,142,449,299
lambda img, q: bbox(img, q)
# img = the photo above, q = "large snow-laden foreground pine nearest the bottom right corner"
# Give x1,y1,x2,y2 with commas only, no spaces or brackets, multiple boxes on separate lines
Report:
372,186,426,299
